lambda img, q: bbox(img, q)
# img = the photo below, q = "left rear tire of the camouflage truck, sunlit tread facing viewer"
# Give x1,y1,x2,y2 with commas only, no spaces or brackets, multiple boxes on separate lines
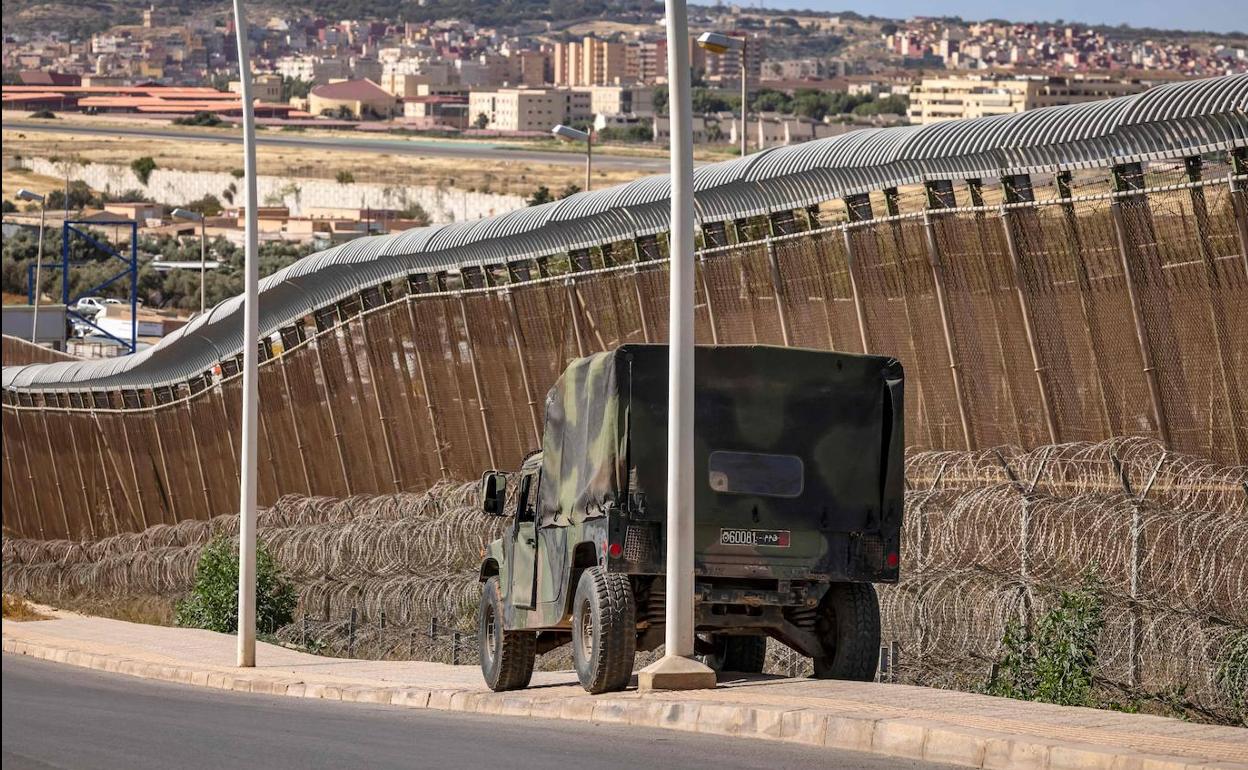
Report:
572,567,636,694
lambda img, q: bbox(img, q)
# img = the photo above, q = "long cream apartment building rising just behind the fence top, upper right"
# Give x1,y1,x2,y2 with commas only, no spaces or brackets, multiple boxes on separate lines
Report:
909,76,1148,125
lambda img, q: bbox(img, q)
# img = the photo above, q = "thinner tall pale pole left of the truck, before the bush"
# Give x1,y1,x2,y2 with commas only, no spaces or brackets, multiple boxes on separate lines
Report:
233,0,260,668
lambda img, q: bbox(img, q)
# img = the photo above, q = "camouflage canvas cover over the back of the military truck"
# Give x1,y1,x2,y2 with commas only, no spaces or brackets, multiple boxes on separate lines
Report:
539,344,904,532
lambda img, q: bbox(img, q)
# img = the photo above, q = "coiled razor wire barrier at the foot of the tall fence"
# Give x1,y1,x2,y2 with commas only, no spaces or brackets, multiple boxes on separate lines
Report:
4,438,1248,723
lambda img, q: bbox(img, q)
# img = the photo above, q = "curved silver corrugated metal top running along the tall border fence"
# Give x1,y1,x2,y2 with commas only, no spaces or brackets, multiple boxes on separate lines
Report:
0,75,1248,391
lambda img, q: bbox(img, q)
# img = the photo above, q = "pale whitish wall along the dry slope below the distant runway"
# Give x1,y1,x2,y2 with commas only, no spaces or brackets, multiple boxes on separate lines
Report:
22,157,524,225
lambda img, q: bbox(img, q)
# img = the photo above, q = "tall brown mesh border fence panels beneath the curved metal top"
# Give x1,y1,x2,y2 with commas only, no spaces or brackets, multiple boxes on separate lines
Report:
2,154,1248,539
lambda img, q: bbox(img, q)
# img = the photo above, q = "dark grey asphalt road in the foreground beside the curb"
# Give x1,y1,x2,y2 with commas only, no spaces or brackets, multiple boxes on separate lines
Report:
0,655,942,770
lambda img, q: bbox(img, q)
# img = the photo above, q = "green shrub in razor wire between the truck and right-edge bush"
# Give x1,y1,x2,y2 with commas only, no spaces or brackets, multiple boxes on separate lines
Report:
986,574,1104,706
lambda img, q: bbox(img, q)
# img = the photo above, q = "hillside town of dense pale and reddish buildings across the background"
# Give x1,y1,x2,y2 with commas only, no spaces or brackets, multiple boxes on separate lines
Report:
4,5,1248,139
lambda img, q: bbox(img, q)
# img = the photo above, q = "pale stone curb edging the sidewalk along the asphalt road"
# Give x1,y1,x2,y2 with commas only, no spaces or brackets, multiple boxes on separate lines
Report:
2,636,1248,770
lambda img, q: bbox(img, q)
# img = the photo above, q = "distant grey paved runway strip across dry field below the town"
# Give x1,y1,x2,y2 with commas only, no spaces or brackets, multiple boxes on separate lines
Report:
4,120,668,172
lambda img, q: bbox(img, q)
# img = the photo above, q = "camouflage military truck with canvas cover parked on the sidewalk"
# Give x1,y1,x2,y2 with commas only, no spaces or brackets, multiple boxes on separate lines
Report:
478,344,904,693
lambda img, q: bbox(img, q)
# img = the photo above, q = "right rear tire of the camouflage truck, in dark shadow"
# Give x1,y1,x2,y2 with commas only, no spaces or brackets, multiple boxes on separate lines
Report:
815,583,880,681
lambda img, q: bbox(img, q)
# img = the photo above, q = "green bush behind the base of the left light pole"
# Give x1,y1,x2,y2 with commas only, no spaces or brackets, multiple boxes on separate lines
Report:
173,537,295,634
